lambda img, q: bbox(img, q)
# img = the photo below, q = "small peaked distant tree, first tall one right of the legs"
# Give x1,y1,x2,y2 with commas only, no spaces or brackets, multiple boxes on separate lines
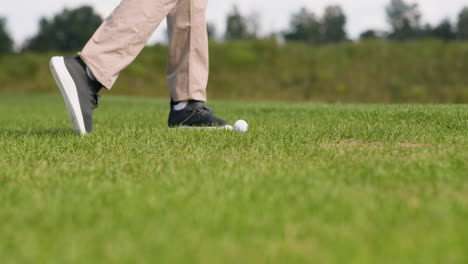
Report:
224,6,257,40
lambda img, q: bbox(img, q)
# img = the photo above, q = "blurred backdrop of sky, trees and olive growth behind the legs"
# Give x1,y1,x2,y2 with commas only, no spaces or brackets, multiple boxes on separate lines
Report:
0,0,468,103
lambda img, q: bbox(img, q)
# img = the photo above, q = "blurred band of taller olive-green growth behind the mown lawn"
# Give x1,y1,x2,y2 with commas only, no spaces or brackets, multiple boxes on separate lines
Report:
0,39,468,104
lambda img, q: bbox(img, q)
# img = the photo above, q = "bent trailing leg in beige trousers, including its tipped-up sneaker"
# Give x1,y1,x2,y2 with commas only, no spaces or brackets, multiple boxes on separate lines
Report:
50,0,179,135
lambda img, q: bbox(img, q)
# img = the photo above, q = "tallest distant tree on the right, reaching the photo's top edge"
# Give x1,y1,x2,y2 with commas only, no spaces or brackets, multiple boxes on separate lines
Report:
386,0,421,40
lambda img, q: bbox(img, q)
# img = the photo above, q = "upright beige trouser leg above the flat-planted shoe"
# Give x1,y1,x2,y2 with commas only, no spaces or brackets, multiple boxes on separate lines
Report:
167,0,209,102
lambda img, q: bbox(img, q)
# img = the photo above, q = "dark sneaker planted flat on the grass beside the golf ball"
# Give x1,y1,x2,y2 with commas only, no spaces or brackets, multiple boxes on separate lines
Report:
168,101,232,129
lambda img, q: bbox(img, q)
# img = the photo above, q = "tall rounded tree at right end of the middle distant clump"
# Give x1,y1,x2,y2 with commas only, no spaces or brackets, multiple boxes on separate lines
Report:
322,6,347,42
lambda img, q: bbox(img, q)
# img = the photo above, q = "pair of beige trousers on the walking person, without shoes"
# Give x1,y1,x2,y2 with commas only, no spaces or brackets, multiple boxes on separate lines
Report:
79,0,208,101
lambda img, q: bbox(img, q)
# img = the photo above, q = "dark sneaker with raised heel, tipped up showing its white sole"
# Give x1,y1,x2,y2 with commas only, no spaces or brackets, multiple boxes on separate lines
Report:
50,57,102,135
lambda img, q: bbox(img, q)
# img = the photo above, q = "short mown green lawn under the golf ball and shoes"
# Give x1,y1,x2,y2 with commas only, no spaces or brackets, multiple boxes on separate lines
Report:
0,93,468,264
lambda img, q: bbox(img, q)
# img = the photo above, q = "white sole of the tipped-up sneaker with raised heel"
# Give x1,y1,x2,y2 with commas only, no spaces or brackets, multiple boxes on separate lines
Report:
50,57,86,135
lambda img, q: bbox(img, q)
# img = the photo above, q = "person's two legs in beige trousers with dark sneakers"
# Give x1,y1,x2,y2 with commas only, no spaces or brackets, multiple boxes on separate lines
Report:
51,0,229,134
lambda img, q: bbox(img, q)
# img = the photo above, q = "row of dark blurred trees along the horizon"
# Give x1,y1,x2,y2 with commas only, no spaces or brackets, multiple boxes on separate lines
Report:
0,0,468,54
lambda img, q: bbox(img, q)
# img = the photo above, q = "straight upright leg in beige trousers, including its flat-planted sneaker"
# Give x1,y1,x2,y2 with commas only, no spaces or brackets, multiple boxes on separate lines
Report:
167,0,231,129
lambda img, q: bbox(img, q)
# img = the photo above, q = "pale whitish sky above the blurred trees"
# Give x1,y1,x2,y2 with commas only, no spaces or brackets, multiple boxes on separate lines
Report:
0,0,468,45
